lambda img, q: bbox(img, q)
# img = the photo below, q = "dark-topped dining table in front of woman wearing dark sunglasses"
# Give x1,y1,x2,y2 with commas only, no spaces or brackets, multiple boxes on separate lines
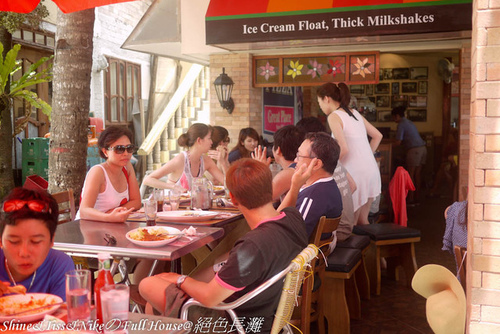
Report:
53,208,250,281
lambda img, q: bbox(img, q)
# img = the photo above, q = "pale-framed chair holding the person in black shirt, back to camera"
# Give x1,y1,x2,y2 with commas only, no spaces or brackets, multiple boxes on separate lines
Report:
181,244,318,334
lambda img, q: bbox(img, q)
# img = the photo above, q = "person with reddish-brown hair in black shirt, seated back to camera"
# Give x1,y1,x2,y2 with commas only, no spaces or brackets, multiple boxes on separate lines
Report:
139,158,307,333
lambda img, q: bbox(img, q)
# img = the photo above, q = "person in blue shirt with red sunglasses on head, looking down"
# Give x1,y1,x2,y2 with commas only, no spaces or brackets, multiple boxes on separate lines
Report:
0,188,75,300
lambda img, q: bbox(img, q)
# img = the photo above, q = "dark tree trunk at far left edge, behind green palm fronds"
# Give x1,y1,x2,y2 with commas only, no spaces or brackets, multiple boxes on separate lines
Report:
0,27,14,199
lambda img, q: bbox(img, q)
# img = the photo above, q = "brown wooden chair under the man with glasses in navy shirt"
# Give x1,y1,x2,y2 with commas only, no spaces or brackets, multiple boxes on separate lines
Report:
292,216,340,334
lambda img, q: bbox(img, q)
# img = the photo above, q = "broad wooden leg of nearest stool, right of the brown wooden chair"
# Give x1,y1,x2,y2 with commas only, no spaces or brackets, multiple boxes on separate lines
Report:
323,274,351,334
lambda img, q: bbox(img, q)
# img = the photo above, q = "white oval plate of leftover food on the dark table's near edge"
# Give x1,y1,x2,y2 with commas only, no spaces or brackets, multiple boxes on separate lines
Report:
125,226,182,247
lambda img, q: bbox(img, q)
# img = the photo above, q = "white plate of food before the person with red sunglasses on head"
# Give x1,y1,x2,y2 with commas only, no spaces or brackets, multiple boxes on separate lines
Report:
0,293,63,322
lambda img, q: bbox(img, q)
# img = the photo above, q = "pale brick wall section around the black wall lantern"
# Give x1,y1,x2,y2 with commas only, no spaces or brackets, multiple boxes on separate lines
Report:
210,53,262,149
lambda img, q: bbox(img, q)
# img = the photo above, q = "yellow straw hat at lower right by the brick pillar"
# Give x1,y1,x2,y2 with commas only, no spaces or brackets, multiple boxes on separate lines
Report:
411,264,466,334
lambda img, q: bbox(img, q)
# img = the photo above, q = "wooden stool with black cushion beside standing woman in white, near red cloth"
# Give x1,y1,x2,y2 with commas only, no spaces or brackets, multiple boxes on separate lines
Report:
353,223,420,295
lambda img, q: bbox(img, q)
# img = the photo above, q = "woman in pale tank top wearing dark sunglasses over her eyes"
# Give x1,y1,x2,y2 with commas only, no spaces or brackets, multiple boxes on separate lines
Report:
76,126,141,222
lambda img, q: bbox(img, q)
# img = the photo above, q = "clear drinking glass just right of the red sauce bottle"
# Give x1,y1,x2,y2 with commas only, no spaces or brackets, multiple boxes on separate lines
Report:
101,284,130,334
